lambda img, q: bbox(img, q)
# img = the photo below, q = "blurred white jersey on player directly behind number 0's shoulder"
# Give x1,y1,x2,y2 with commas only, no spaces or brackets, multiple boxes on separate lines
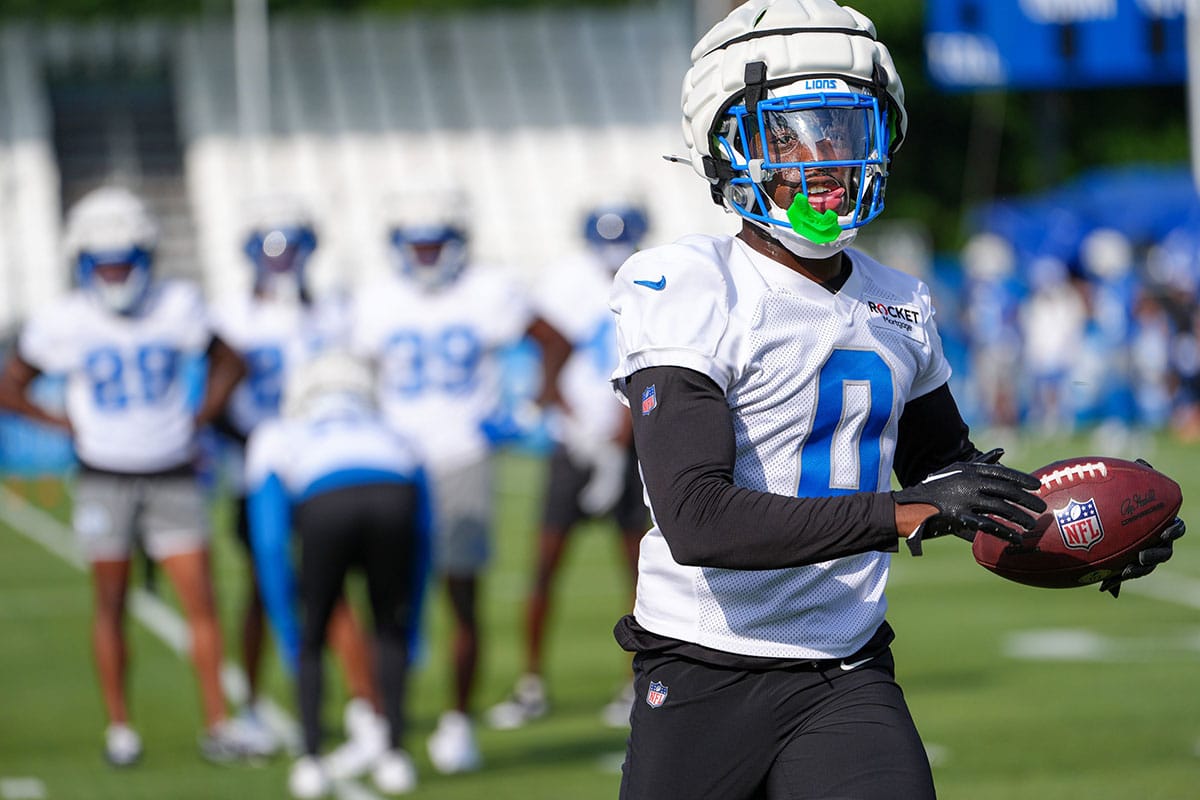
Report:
534,253,629,441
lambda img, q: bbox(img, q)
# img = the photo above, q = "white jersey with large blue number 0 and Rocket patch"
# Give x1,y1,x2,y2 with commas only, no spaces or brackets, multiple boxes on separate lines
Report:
611,236,950,658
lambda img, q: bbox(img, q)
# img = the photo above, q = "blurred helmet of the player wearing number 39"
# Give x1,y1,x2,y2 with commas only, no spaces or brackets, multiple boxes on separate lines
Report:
386,187,468,291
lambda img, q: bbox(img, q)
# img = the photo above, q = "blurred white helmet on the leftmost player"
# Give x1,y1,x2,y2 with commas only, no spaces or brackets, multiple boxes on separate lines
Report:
64,186,158,314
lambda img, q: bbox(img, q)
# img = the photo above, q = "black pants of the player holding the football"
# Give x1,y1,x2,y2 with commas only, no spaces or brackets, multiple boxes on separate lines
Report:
620,650,935,800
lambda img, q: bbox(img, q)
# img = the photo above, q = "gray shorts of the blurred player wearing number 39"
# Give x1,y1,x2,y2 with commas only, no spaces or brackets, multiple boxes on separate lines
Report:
430,458,492,577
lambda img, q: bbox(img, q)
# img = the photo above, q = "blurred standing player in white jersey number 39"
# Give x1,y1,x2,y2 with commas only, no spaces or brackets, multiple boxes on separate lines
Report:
354,187,570,772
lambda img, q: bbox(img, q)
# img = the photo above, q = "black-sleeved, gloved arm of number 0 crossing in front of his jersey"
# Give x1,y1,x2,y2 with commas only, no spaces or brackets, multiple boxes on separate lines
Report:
625,367,1040,570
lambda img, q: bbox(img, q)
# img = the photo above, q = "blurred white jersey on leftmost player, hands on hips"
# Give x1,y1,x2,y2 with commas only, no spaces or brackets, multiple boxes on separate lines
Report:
18,281,212,473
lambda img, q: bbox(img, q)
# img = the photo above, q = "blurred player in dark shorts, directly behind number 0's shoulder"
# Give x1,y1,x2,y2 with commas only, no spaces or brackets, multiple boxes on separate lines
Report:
487,203,648,729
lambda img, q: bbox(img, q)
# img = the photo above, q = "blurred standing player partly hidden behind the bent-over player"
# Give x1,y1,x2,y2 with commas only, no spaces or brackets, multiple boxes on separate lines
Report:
212,194,385,762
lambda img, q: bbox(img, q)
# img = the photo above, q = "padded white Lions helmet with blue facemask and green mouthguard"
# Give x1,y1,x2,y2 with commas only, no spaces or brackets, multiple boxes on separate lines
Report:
683,0,907,258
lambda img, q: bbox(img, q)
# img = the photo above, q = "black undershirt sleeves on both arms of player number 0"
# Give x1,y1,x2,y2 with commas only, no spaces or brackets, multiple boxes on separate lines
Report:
625,367,977,570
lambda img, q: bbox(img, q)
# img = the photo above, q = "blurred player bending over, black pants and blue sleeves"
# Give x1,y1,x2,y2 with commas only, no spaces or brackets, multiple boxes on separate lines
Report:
247,350,428,798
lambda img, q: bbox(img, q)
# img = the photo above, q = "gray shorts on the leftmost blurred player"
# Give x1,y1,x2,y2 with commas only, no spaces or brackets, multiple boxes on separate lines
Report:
73,468,210,561
